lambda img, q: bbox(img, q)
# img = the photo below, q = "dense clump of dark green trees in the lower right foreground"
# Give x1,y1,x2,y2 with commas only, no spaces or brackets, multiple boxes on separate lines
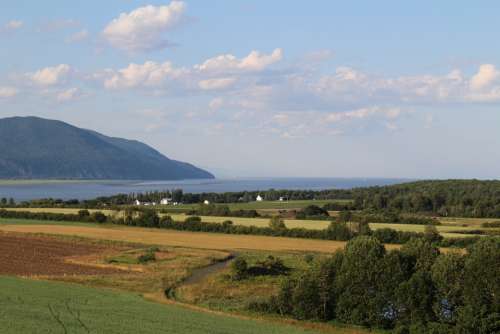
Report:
248,236,500,334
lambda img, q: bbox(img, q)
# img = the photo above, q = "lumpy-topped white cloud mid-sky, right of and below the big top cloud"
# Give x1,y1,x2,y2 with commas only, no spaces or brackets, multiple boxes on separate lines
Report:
195,49,283,72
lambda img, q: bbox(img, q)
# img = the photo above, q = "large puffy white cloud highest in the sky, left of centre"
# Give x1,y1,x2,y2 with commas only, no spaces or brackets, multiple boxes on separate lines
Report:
103,1,186,52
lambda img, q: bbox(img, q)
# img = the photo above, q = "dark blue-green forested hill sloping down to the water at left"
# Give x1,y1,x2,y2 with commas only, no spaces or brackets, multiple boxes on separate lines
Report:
0,117,214,180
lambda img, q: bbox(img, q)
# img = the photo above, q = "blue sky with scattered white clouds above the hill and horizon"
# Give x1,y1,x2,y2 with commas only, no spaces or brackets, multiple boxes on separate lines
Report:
0,0,500,179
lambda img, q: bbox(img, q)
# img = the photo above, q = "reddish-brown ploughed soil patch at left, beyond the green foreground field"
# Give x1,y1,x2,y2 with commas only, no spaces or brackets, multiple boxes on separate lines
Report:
0,233,123,276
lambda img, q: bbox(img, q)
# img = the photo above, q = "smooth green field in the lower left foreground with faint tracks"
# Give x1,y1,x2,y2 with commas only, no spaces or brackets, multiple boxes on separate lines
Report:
0,277,316,334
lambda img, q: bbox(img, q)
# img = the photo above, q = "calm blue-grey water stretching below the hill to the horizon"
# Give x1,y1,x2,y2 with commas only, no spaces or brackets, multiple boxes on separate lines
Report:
0,178,409,201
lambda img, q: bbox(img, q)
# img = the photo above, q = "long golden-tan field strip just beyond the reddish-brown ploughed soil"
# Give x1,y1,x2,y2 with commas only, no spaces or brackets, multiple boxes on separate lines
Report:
0,225,399,253
